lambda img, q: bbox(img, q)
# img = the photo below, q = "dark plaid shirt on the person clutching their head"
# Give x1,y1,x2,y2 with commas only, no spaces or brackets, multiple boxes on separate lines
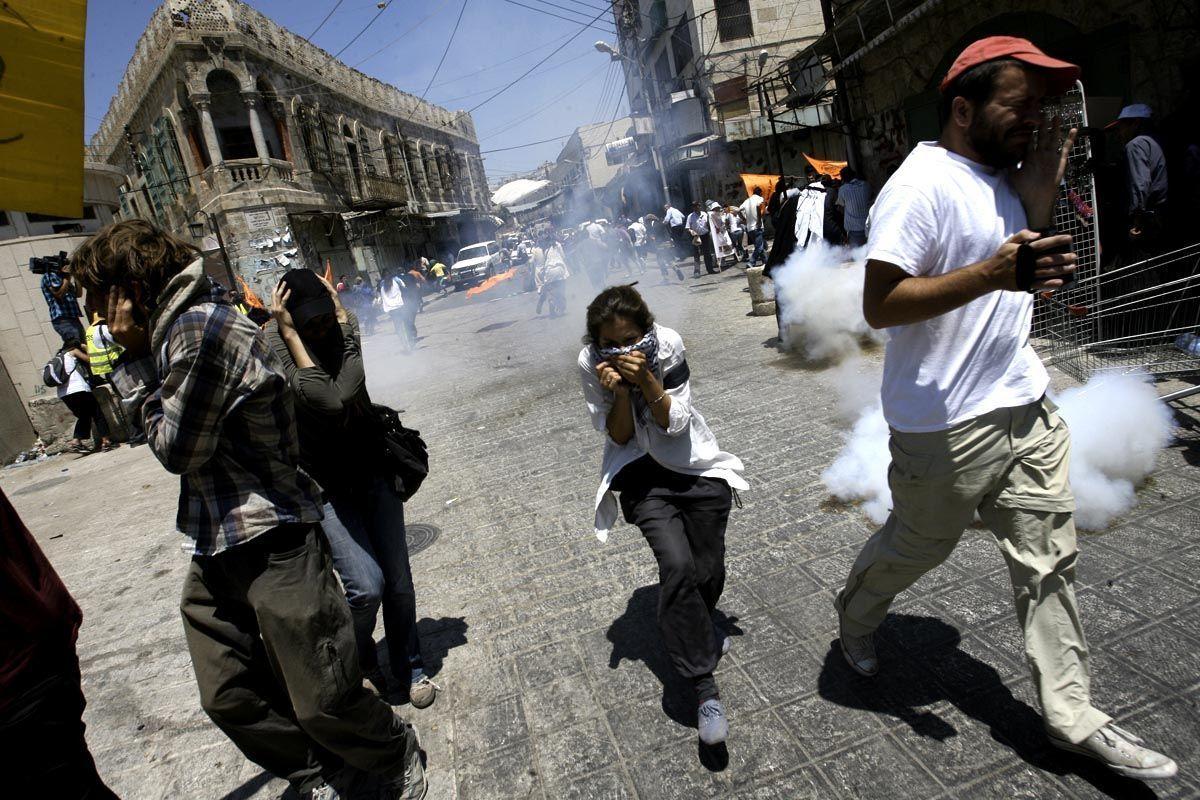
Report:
113,297,323,555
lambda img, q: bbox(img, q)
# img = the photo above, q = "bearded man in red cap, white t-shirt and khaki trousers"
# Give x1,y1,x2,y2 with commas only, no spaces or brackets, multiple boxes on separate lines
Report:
835,36,1177,778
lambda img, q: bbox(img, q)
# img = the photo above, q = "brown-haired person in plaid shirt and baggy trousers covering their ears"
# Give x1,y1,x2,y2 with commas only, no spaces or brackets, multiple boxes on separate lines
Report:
71,219,426,800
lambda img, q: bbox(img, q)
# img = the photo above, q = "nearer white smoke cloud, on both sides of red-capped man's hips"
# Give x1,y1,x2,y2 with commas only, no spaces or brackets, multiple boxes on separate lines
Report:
821,374,1174,530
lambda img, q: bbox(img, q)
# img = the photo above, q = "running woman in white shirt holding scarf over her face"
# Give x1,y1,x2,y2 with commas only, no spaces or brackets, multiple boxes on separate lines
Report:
578,285,746,745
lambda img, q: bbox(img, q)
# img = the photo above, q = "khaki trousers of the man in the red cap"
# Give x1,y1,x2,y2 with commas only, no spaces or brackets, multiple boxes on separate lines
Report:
836,399,1110,742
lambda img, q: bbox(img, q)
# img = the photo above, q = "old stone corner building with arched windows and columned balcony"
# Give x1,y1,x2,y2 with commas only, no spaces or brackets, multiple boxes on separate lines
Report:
91,0,494,294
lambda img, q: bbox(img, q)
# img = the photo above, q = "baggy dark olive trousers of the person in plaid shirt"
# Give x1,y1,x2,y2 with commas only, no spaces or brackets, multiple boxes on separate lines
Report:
180,525,416,793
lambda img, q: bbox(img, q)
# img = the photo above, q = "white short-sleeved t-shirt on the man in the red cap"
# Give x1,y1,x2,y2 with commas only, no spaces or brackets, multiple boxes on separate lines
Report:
866,142,1050,433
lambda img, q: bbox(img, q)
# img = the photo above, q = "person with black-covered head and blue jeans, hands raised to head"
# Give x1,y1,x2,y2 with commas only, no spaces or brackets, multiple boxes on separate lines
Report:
265,270,438,709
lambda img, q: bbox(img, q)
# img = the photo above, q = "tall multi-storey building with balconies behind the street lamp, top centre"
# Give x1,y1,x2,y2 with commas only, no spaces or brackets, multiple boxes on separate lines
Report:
613,0,845,207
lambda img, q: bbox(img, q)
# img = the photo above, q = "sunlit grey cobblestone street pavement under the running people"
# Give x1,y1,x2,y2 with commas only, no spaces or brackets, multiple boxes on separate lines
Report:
0,260,1200,800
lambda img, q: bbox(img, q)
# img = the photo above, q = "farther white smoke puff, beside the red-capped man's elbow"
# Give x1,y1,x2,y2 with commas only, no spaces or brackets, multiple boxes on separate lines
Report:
772,240,882,361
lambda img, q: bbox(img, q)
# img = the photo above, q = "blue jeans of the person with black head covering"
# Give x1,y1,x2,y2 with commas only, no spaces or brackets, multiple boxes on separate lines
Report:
320,477,425,682
